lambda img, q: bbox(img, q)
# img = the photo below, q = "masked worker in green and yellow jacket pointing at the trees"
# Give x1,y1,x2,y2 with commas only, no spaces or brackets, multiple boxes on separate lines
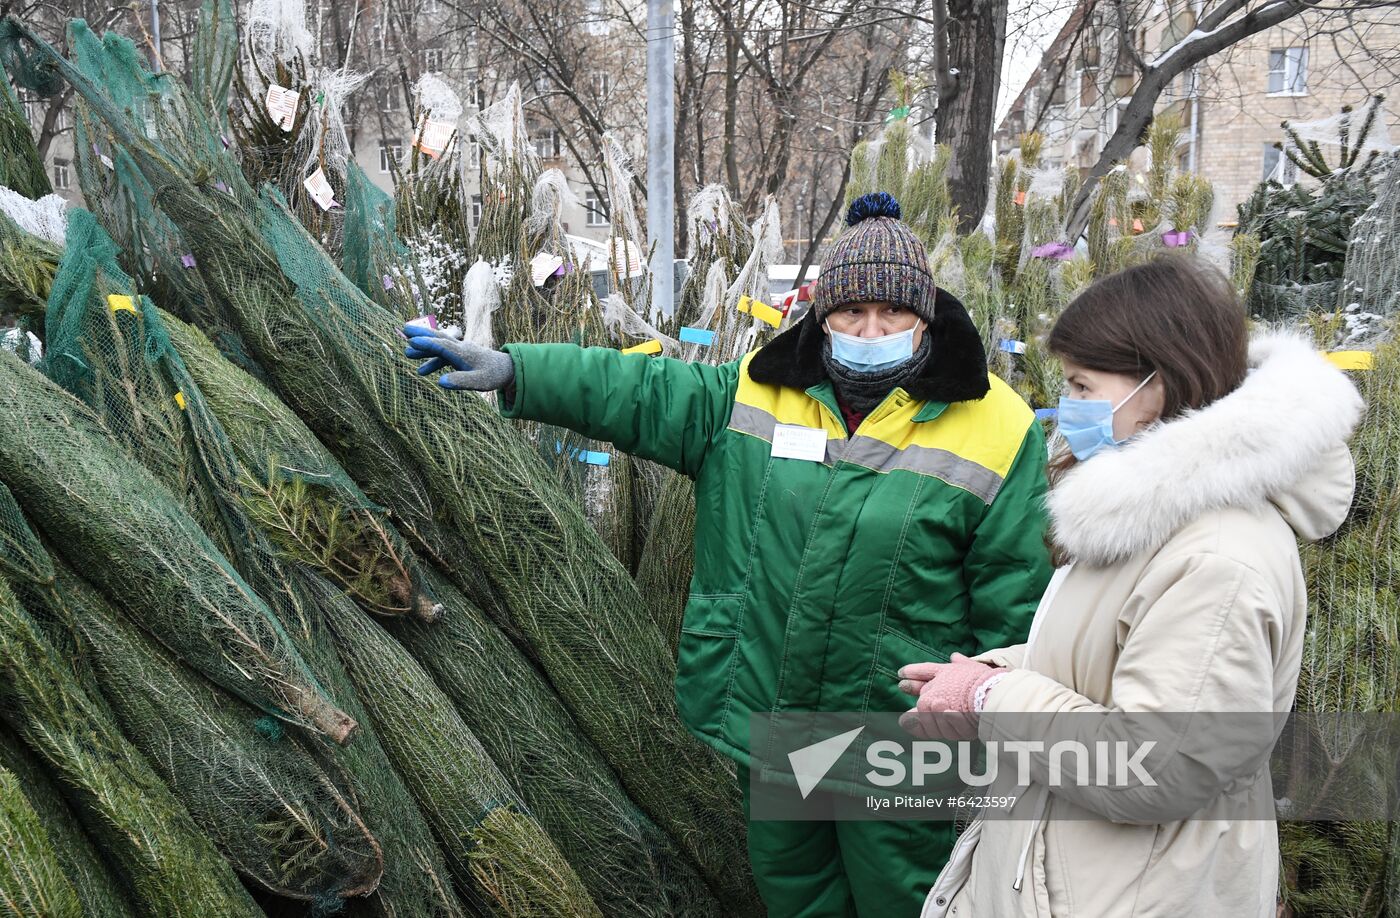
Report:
405,193,1050,918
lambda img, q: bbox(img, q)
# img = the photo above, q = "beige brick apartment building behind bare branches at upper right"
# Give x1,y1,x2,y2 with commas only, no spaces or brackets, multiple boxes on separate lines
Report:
997,0,1400,221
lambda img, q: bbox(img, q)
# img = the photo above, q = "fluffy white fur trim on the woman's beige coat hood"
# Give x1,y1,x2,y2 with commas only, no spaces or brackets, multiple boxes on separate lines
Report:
1047,333,1364,565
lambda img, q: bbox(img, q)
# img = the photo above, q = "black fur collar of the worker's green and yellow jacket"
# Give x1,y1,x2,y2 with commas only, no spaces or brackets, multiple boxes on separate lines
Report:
749,288,991,402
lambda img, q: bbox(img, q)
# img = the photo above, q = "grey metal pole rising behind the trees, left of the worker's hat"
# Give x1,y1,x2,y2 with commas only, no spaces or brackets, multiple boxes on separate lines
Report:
647,0,676,316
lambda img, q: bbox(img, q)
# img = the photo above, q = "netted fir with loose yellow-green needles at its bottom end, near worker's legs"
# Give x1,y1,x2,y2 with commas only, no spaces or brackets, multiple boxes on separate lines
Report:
308,577,602,918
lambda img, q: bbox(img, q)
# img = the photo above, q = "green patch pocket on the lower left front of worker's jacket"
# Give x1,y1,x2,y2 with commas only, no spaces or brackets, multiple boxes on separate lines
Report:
676,593,743,735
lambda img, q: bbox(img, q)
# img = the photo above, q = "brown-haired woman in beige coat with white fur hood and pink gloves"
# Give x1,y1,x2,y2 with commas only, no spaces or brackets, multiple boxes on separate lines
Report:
900,257,1362,918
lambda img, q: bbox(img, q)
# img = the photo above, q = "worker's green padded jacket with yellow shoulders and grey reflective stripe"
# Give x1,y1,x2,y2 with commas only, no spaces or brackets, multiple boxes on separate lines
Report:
503,338,1050,765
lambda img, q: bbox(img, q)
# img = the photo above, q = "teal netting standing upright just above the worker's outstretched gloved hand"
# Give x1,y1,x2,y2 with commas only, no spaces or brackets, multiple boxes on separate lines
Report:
340,160,426,320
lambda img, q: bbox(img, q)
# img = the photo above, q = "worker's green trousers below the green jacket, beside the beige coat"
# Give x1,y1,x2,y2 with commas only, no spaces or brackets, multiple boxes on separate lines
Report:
739,765,955,918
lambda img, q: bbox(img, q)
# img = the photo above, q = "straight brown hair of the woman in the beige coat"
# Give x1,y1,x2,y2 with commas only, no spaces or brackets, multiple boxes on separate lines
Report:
1049,255,1249,564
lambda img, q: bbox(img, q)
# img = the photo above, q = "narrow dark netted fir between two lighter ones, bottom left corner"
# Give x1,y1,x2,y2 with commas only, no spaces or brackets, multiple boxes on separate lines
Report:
0,723,136,918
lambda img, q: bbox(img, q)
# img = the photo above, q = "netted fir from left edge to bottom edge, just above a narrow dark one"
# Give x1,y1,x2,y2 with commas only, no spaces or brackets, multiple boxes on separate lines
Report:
0,579,262,918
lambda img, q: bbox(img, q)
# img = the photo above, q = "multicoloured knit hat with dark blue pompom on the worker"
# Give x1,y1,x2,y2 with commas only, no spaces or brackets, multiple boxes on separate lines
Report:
812,192,938,322
